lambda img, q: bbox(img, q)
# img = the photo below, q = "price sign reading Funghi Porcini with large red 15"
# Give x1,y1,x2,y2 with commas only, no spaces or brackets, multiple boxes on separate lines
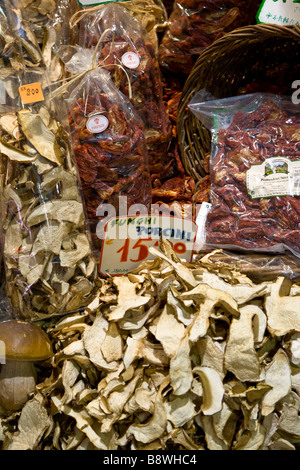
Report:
99,216,197,276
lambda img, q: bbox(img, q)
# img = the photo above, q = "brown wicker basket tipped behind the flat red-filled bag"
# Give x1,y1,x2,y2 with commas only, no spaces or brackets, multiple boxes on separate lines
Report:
177,24,300,182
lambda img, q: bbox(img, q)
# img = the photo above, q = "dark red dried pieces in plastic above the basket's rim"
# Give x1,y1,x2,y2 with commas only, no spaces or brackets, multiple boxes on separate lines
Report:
159,0,261,75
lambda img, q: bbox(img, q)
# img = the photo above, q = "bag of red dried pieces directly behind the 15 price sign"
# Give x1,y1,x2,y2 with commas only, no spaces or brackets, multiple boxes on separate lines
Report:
66,68,152,258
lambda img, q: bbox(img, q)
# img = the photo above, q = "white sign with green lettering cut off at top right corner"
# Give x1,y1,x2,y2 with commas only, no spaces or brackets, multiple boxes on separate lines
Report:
256,0,300,26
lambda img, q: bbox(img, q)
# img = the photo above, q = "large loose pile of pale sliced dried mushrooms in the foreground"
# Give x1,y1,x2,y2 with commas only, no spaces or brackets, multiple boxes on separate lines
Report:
0,242,300,450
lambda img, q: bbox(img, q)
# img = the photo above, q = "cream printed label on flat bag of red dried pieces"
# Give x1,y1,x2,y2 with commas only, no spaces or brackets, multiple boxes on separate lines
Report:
246,157,300,199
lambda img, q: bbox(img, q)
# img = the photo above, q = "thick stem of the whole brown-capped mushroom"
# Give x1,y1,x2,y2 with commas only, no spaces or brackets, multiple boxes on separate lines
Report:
0,360,36,411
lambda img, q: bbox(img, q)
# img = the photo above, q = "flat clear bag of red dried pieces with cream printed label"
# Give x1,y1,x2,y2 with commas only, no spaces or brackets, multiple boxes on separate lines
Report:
189,91,300,257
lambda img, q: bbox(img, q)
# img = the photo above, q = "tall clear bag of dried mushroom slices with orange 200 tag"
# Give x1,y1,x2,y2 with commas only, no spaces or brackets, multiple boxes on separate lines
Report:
0,2,96,319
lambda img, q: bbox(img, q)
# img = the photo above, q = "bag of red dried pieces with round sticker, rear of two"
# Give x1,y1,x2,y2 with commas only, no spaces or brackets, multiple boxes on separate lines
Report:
73,4,172,178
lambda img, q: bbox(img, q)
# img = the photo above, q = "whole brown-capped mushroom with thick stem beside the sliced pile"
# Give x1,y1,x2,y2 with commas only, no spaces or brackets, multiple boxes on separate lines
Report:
0,320,53,411
